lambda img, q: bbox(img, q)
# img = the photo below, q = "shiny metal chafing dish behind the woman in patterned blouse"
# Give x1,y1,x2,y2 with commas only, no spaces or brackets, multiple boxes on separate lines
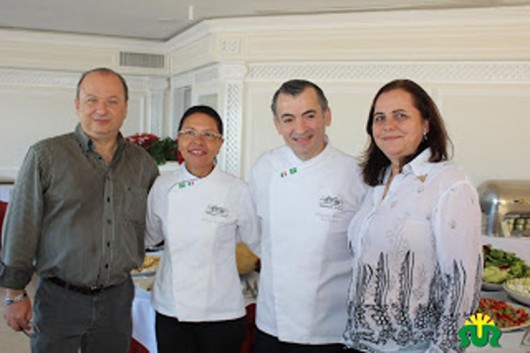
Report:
478,180,530,237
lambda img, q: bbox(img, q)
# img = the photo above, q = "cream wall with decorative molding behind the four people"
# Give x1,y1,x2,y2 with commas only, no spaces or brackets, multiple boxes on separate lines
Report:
0,6,530,185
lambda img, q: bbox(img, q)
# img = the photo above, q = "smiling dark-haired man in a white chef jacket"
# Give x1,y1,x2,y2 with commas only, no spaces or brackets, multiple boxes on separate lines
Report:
249,80,366,353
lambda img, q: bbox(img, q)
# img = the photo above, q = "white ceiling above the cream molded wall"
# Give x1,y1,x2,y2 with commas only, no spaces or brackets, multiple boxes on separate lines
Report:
0,0,530,41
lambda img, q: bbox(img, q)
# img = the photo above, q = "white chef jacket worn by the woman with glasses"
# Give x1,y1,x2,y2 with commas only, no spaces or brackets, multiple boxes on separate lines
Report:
146,165,259,322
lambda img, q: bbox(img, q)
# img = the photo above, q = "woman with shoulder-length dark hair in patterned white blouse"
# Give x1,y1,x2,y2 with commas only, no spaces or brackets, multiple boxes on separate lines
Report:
344,80,482,353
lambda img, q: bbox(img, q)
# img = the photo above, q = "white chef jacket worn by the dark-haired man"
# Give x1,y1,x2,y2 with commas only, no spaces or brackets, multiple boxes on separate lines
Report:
249,144,366,344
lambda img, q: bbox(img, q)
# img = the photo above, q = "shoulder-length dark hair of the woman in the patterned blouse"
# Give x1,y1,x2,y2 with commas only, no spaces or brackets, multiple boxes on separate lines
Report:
361,79,451,186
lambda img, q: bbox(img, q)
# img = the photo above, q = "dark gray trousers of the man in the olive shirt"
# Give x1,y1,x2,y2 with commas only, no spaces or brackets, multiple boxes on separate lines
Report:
31,278,134,353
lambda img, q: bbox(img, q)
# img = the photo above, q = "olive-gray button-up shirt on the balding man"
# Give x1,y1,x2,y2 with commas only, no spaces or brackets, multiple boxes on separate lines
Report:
0,125,158,289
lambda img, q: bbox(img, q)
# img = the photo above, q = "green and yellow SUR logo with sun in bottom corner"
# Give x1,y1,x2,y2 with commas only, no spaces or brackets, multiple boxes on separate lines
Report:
458,313,502,348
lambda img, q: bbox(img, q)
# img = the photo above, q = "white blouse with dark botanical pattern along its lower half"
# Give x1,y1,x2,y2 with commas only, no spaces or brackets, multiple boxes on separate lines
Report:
344,149,482,353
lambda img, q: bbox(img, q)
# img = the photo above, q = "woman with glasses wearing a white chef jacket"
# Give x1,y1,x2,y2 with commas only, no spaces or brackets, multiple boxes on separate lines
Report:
146,106,259,353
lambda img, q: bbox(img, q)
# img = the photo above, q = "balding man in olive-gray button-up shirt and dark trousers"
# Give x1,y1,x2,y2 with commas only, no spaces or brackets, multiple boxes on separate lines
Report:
0,68,158,353
